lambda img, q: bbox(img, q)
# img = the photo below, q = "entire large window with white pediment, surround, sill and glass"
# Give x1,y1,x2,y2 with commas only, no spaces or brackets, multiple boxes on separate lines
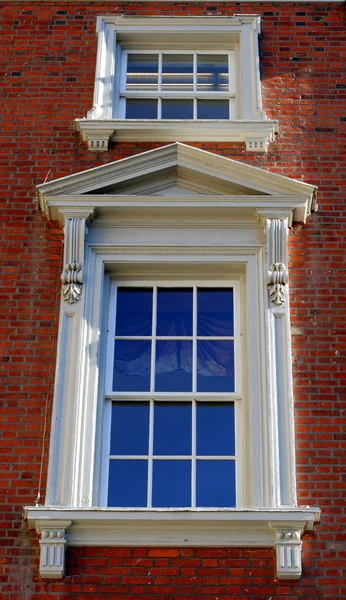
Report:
26,143,319,579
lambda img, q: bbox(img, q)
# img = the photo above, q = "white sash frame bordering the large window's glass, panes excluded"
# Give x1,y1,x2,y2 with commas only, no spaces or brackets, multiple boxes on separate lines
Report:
99,279,244,508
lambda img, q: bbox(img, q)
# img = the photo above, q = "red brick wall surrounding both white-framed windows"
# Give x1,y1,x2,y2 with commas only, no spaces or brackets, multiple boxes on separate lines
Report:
0,0,346,600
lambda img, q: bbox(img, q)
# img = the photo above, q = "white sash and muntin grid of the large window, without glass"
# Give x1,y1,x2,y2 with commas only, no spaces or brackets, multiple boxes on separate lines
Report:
100,280,243,510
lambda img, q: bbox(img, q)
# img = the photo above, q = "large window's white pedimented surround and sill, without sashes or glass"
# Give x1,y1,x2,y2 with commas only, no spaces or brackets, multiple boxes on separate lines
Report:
26,144,320,579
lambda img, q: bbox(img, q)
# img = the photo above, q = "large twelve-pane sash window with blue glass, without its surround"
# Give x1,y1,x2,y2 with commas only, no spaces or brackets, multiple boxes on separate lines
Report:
102,282,240,508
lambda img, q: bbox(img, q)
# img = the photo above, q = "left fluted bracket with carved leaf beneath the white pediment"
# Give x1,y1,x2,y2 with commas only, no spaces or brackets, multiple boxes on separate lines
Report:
61,217,86,304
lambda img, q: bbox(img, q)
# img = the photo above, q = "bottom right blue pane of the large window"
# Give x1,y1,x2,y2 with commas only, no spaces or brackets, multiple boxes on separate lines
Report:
196,460,236,508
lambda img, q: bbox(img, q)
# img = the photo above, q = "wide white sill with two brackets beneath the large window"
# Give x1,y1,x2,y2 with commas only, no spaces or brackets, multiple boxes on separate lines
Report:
25,506,320,579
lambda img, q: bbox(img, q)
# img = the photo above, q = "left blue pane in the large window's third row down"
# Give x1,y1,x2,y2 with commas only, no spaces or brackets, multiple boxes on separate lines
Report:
110,402,149,455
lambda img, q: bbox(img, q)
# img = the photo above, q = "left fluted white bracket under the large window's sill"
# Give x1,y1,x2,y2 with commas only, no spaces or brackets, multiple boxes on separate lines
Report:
36,520,72,579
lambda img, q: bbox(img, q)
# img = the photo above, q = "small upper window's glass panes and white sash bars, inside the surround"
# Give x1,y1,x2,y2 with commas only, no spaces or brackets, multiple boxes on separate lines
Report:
119,50,236,120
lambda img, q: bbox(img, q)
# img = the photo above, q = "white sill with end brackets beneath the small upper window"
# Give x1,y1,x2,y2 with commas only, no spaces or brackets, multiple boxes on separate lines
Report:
75,119,278,152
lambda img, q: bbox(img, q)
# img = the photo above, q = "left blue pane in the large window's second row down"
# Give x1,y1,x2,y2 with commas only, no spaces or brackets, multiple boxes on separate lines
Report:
113,340,151,392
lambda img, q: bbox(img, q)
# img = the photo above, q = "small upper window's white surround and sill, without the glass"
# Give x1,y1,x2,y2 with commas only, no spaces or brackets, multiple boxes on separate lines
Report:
75,15,277,152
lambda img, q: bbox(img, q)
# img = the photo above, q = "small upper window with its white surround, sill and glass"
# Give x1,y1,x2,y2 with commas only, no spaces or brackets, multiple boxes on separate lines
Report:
75,15,277,152
